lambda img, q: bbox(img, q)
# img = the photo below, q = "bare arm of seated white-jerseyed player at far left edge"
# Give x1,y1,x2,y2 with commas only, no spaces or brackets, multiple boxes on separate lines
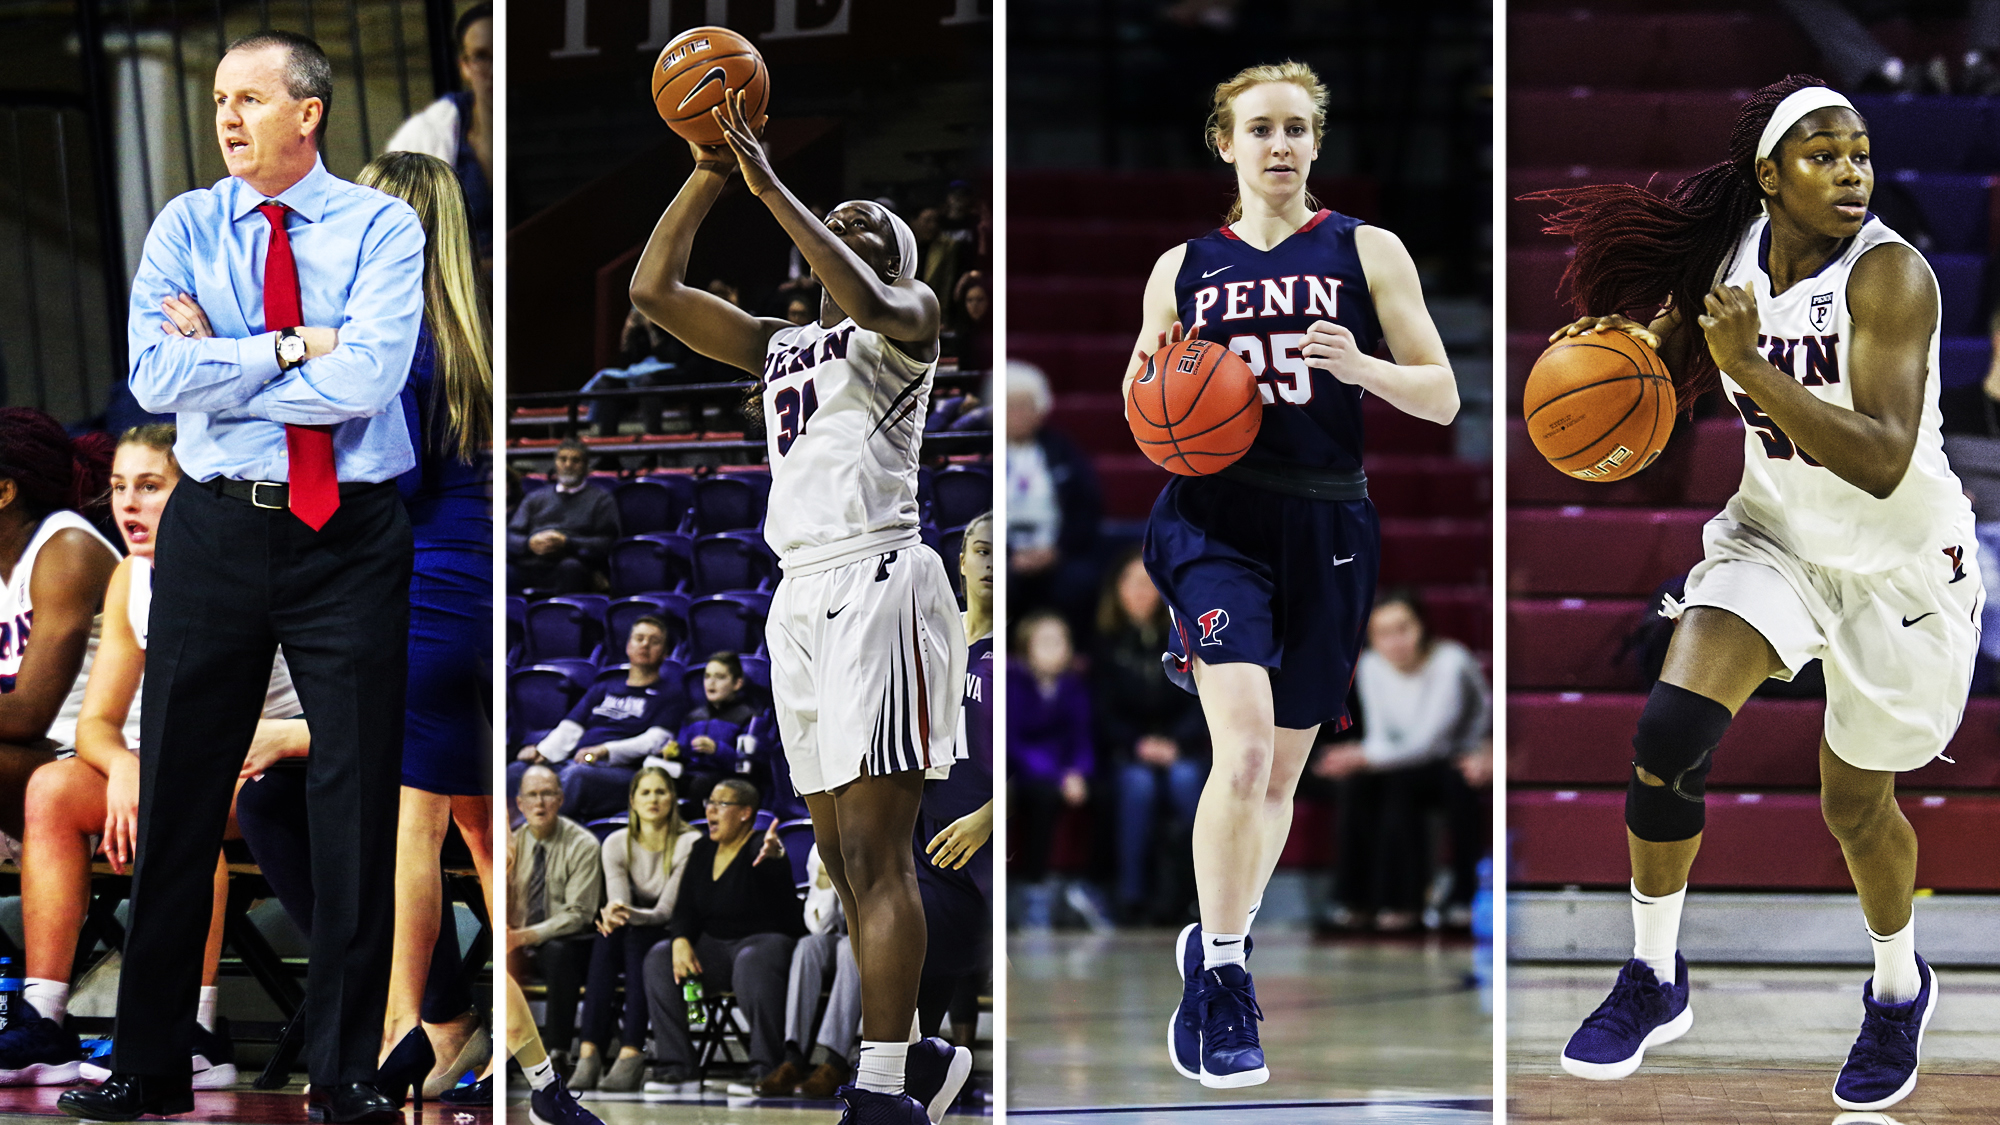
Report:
0,530,118,745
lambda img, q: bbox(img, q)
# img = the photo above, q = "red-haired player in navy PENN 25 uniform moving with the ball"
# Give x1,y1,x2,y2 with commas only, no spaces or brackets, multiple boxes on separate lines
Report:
1124,62,1458,1089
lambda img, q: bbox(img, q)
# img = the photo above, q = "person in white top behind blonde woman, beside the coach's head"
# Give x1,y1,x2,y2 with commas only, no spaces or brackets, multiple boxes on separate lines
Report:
384,4,494,266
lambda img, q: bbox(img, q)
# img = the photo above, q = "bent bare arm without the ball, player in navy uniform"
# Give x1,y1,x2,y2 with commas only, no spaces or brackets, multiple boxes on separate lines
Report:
1300,226,1458,424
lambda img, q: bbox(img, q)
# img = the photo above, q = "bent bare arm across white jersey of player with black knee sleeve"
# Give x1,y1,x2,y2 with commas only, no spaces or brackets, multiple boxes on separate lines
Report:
1700,244,1938,500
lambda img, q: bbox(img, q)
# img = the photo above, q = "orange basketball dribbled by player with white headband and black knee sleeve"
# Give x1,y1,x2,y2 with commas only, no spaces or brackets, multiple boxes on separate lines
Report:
1522,332,1674,480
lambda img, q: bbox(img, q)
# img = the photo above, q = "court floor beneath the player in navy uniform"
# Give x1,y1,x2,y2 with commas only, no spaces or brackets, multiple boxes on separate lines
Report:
1008,931,1492,1125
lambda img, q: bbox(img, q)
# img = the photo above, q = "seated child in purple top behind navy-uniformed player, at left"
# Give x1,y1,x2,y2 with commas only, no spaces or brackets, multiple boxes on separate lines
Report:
1006,611,1096,929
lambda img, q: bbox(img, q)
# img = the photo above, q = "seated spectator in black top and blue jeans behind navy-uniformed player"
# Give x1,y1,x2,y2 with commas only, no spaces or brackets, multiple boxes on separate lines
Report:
1090,546,1208,925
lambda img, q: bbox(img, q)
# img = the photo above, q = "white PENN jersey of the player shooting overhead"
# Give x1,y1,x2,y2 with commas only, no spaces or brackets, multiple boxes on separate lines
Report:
764,318,938,575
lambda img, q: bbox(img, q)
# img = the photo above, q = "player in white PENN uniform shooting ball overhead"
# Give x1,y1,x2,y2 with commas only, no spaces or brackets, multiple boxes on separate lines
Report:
632,92,966,1125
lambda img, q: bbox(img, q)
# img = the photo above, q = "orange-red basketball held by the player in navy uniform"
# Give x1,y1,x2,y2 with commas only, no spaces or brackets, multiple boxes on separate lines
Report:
1126,332,1264,476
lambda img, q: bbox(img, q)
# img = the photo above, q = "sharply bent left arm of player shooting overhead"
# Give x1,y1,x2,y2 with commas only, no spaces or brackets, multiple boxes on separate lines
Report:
632,146,786,374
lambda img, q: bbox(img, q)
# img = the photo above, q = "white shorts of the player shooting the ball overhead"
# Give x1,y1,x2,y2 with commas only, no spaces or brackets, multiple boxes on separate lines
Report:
764,544,966,793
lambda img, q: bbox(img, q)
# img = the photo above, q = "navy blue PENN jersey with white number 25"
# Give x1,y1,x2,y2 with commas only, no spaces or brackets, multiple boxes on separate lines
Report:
1174,210,1382,472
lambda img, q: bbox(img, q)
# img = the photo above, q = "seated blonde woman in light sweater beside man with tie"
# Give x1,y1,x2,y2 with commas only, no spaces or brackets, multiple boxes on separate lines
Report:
570,767,702,1093
